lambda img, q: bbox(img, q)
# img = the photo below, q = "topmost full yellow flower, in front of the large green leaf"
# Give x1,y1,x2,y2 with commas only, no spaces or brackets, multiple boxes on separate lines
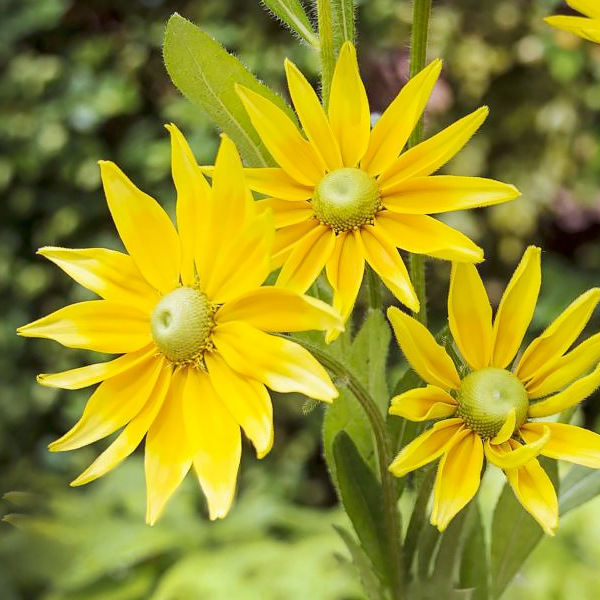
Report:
238,42,519,340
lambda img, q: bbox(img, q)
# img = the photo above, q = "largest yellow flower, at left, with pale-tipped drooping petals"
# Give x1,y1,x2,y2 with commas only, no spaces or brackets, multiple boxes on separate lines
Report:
19,125,342,524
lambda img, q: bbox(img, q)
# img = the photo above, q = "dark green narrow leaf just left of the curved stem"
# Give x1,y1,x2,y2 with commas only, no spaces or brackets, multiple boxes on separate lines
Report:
333,431,389,581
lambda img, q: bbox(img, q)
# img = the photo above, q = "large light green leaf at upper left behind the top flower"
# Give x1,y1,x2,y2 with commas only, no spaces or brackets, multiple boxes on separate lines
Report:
163,13,292,167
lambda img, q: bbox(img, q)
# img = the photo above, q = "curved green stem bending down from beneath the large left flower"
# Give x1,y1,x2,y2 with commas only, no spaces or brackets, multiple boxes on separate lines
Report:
294,339,404,600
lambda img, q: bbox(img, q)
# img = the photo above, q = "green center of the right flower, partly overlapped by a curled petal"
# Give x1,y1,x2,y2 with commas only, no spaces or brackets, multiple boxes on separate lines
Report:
457,367,529,439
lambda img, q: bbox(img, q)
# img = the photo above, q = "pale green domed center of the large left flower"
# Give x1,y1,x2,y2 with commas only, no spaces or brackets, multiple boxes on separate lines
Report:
150,287,215,363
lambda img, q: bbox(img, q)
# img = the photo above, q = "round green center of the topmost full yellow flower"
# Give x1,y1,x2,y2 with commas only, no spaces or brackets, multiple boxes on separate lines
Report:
312,168,381,233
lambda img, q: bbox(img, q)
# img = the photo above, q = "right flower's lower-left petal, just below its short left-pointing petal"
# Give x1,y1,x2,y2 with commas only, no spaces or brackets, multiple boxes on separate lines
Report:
389,419,469,477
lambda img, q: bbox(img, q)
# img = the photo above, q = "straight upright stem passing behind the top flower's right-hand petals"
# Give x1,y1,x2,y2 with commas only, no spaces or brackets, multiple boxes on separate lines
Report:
408,0,432,325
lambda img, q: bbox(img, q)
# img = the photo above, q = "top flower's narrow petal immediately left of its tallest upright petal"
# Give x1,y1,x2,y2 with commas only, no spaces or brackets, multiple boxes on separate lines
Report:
284,59,343,171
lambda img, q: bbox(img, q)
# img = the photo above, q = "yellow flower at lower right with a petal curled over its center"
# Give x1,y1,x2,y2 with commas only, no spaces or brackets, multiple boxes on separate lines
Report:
388,246,600,534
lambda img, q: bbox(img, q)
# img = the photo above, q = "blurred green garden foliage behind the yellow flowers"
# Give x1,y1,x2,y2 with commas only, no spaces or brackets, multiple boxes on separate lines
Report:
0,0,600,600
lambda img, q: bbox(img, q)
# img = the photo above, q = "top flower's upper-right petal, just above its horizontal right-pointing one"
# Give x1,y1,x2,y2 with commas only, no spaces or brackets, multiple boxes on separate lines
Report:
377,106,489,188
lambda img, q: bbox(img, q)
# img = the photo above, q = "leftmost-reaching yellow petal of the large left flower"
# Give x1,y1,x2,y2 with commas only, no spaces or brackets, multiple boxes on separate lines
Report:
17,300,152,354
